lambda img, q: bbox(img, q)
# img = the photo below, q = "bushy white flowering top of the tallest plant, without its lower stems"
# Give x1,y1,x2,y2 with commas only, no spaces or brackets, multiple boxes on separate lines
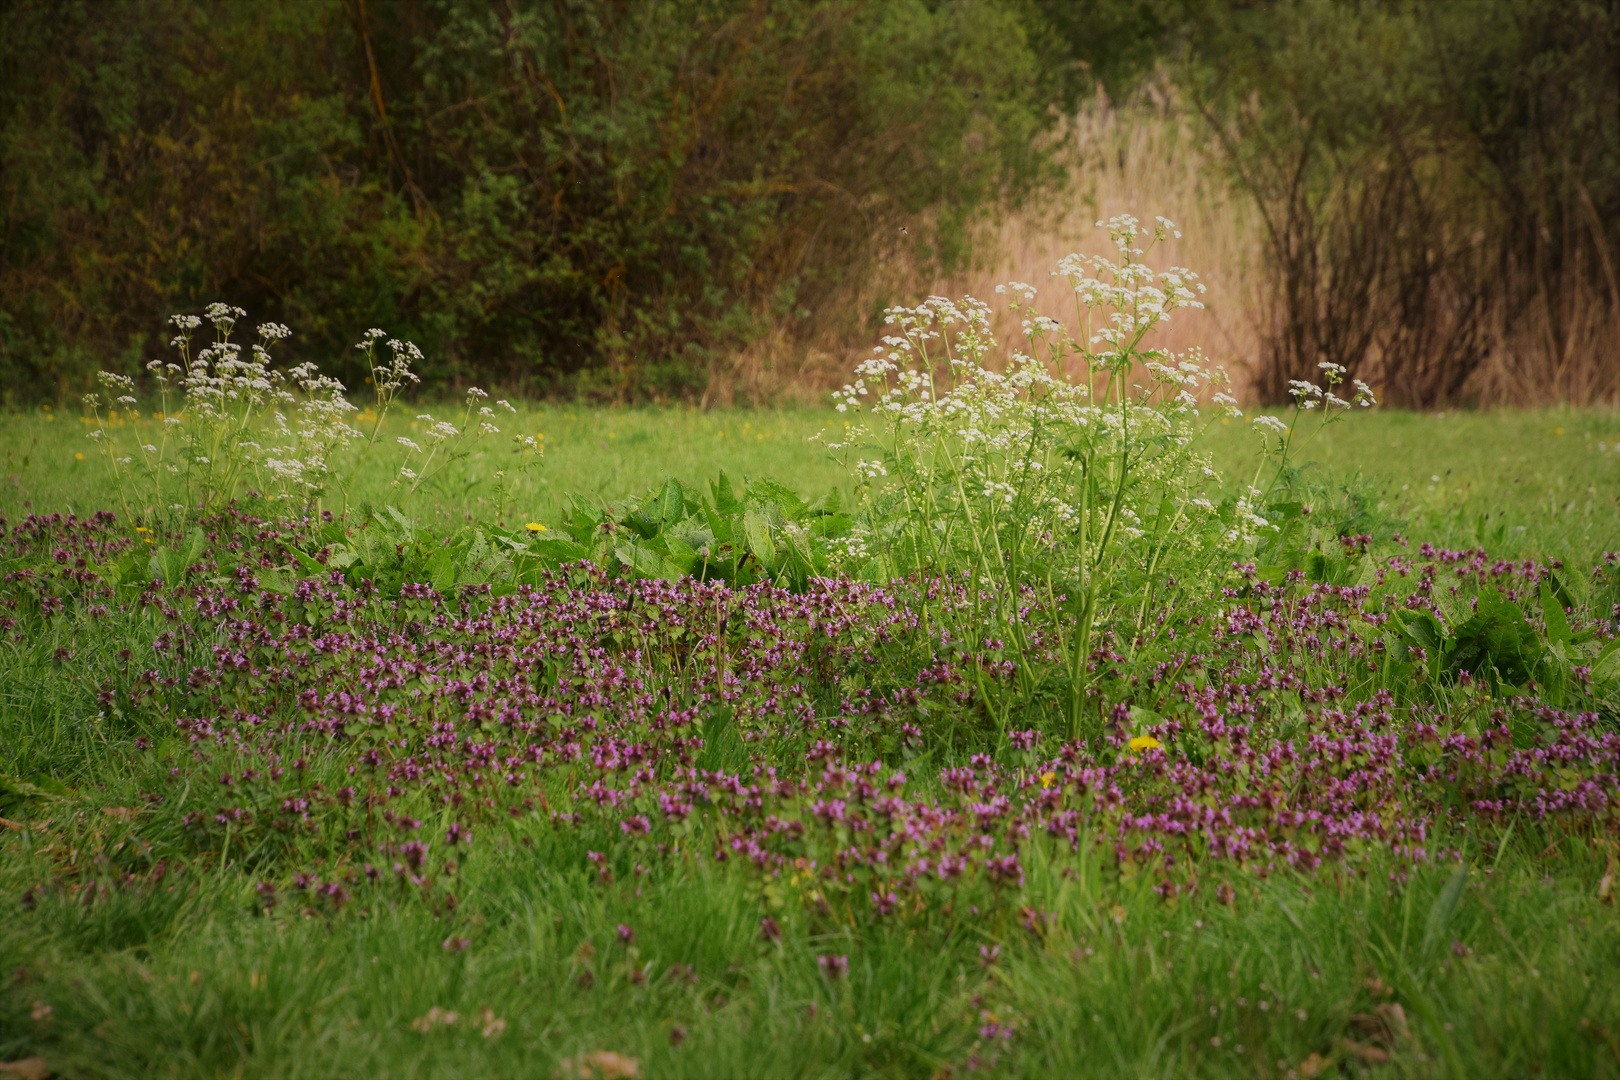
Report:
829,217,1241,592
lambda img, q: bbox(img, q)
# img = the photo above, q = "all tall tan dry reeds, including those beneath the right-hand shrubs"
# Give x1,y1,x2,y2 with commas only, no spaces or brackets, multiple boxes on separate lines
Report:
705,81,1620,408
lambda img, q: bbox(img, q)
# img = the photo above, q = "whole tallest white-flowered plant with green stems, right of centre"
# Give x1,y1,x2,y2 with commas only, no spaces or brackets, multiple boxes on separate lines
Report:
829,217,1374,737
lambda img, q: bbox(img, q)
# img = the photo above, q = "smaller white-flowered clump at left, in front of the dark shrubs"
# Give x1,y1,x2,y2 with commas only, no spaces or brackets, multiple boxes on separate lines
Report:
84,303,539,518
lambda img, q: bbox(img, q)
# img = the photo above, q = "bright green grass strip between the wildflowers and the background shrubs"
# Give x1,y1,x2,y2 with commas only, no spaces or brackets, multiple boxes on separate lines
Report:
0,406,1620,562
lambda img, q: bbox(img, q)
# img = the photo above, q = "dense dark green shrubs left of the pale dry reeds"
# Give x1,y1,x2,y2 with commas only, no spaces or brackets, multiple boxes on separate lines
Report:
0,0,1038,397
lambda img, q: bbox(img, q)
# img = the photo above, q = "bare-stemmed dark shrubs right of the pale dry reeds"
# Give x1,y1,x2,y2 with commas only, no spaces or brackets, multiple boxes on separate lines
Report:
1178,0,1620,408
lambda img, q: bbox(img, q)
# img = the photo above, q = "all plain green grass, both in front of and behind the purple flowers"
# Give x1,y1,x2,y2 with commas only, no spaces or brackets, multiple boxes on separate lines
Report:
0,410,1620,1077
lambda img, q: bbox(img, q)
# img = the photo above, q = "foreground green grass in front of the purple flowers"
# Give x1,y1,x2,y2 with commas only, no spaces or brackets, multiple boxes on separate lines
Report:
0,822,1620,1077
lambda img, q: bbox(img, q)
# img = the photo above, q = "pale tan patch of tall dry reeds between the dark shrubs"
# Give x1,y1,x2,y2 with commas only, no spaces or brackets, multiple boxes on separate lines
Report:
719,84,1264,405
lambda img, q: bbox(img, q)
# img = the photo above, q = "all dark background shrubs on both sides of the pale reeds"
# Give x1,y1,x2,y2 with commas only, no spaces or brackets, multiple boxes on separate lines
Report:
0,0,1620,406
